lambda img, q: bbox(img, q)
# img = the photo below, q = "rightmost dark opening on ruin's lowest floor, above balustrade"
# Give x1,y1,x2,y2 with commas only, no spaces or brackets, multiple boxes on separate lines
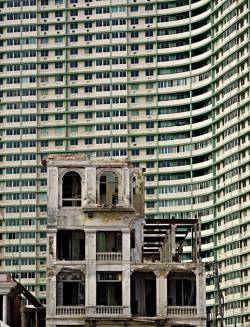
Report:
168,272,196,306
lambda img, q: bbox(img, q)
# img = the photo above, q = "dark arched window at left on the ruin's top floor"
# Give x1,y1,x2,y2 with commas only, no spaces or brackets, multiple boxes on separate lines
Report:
62,171,81,207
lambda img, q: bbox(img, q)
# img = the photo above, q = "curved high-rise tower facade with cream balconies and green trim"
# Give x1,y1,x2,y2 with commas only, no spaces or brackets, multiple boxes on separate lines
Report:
0,0,250,326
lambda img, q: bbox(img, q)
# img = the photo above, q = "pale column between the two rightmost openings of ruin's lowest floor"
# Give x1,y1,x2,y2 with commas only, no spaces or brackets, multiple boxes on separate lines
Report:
155,271,168,316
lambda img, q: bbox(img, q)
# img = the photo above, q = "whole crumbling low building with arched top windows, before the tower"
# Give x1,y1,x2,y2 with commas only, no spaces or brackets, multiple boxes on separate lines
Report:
46,155,206,327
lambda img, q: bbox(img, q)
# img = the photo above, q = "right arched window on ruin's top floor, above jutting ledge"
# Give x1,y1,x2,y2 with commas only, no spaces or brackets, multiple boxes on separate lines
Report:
99,171,118,206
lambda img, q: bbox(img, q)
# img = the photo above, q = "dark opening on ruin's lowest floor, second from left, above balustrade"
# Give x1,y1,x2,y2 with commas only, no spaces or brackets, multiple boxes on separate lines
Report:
96,272,122,306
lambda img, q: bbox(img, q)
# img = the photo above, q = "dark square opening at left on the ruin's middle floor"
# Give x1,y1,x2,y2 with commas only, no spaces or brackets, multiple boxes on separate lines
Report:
57,230,85,260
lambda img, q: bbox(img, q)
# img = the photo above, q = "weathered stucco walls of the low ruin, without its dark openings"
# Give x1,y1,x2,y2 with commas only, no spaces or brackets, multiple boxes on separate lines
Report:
47,155,206,327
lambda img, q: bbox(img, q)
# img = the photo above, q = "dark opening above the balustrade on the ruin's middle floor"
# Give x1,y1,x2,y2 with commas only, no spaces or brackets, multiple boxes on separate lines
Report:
96,231,122,253
